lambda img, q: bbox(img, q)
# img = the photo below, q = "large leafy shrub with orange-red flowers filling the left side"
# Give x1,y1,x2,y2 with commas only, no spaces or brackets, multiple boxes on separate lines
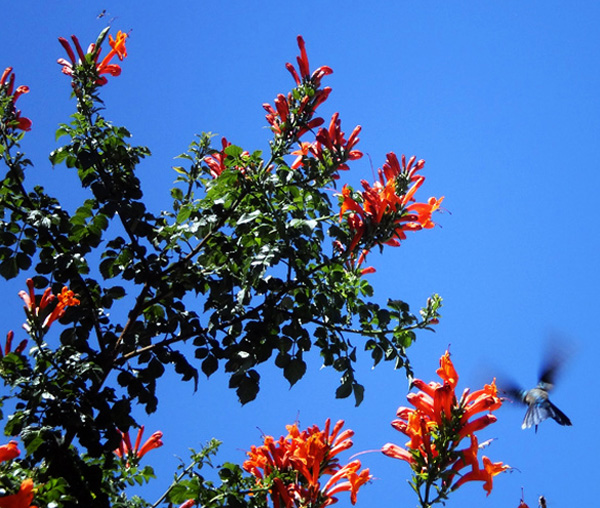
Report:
0,25,450,508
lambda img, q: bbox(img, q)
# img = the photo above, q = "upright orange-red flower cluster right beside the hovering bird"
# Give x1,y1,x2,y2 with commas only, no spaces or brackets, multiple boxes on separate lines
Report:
382,352,509,503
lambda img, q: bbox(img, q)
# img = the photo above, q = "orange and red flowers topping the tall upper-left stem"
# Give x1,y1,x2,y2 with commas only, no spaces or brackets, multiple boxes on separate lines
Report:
57,30,128,85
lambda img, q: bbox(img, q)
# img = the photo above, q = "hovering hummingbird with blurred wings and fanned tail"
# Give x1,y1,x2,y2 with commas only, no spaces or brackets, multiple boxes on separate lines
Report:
503,342,572,432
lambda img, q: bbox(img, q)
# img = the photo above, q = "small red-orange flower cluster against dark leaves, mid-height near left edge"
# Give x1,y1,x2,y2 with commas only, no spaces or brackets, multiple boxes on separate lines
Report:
19,279,81,330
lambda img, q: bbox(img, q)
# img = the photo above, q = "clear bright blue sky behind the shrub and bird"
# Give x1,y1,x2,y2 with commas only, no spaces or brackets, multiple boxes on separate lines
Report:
0,0,600,508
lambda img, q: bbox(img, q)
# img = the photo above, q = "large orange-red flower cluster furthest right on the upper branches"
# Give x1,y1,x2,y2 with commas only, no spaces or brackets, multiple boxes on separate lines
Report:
340,152,444,268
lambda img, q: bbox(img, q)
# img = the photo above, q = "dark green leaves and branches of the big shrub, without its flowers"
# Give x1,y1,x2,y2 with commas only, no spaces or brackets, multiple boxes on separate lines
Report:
0,32,440,507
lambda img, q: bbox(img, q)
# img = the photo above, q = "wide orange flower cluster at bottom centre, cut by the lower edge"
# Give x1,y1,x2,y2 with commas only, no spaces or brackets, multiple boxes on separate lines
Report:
243,419,371,508
